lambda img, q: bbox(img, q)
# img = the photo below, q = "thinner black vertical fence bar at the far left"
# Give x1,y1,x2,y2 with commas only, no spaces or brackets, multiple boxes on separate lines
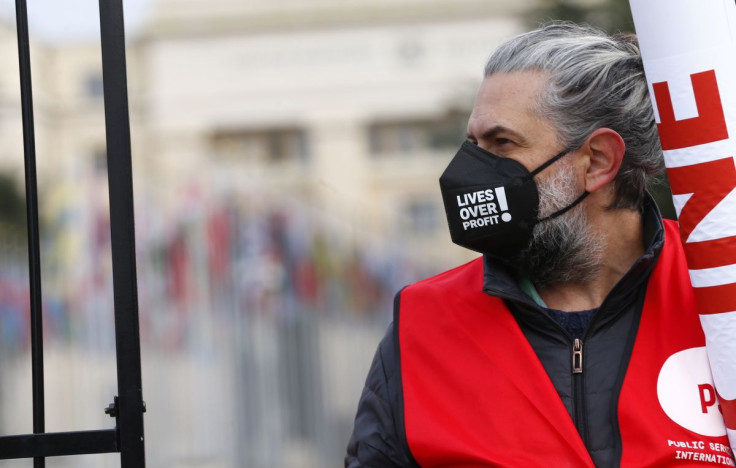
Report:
15,0,46,468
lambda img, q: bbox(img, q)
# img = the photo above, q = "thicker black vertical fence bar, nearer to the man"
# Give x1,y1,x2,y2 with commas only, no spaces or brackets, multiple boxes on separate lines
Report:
99,0,145,468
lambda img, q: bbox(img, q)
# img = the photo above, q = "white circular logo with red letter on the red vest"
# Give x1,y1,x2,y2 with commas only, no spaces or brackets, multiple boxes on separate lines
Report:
657,347,726,437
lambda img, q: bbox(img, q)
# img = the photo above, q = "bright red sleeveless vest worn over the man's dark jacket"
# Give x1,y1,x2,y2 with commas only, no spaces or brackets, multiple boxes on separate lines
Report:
398,222,734,467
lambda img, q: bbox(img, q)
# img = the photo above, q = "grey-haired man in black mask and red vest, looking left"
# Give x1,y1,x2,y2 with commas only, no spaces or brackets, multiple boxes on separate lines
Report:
345,23,733,467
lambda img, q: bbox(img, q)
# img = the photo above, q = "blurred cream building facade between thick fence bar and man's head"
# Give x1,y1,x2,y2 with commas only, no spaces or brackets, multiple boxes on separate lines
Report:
137,0,531,264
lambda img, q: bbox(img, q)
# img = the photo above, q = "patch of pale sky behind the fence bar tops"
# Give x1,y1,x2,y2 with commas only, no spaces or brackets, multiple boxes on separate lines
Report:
0,0,151,41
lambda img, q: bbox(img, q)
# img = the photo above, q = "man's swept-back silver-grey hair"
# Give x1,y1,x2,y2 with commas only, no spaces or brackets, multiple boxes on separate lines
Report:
485,22,664,209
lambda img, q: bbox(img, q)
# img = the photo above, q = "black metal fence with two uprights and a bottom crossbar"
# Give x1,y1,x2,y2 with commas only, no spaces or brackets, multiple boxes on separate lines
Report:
0,0,145,468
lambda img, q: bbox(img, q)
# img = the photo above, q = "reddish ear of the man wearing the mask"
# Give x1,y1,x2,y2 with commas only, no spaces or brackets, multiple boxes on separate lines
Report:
581,128,626,193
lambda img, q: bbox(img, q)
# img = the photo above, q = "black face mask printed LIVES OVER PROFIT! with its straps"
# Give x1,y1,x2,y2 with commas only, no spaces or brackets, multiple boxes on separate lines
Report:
440,141,588,260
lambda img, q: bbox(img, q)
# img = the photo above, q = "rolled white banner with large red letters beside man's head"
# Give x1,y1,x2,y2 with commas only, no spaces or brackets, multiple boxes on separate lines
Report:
630,0,736,448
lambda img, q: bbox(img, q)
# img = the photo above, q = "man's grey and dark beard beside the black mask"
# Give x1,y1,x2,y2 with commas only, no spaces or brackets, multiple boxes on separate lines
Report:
512,161,603,288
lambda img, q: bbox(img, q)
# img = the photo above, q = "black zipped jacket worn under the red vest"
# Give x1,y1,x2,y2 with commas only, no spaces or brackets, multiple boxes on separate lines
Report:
345,198,664,468
